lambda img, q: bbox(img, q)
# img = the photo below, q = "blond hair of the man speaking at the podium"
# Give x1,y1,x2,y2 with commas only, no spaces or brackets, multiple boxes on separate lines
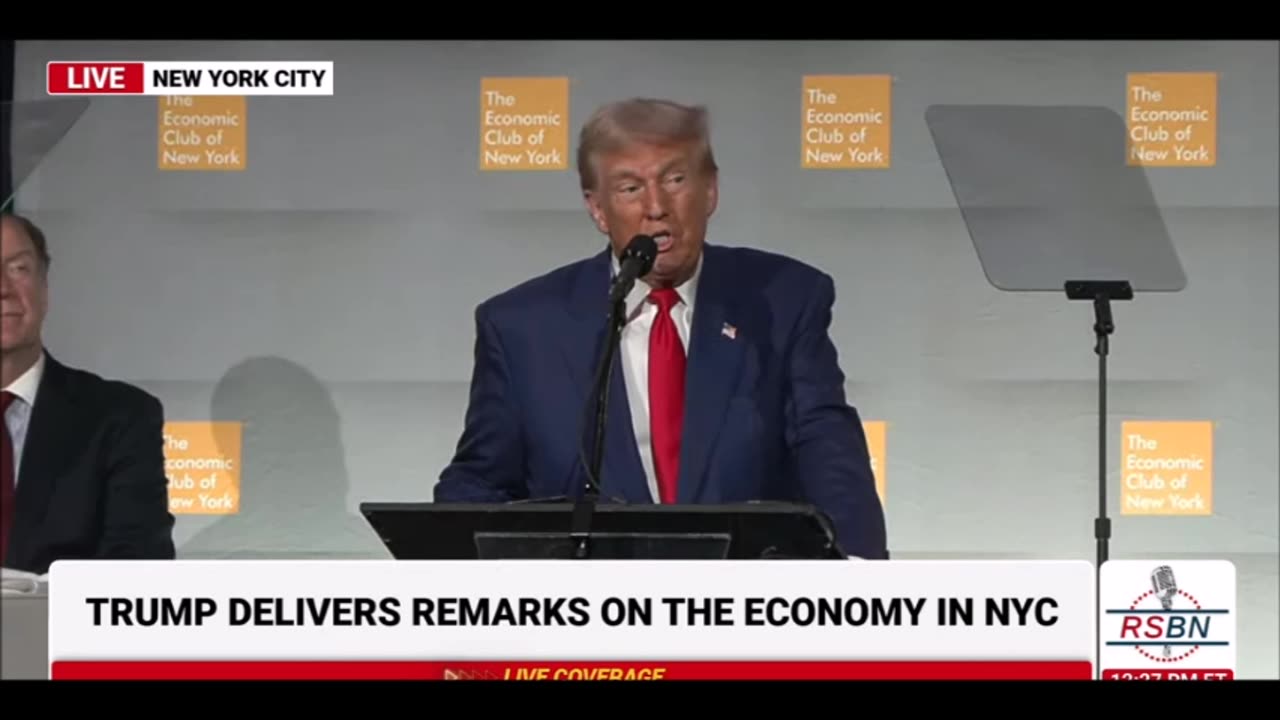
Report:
577,97,718,191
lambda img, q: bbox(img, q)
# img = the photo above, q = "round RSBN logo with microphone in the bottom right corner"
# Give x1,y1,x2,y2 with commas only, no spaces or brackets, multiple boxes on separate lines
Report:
1106,565,1230,662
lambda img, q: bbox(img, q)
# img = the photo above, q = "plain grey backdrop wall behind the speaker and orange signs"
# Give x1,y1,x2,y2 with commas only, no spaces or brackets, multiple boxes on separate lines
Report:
15,42,1280,676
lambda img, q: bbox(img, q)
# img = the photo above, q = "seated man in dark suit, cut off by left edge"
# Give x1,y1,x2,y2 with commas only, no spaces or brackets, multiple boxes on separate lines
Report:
0,208,175,574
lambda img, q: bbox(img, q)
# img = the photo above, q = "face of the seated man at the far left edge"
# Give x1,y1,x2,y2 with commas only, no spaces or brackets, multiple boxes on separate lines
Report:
0,217,49,352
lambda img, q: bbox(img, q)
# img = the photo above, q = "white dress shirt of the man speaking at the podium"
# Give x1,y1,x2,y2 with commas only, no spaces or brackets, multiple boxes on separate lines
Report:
613,258,701,502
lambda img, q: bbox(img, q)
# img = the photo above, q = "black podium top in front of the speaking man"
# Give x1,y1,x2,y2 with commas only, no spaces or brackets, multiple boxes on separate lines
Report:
360,502,847,560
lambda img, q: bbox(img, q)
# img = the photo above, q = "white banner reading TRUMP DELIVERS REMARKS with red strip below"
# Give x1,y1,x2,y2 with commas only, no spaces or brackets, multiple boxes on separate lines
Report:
49,560,1097,680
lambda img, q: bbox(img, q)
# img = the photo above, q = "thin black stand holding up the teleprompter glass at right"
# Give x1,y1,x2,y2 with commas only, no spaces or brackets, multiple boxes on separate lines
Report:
1065,281,1133,678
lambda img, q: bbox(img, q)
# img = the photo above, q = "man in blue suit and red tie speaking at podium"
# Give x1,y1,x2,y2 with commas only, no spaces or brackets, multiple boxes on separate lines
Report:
434,99,887,559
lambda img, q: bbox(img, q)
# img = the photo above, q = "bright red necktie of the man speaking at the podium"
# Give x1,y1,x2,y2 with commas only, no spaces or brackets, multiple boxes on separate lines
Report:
649,288,685,502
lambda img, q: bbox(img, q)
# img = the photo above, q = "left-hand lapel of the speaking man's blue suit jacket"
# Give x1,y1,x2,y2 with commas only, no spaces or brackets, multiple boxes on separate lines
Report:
559,250,653,502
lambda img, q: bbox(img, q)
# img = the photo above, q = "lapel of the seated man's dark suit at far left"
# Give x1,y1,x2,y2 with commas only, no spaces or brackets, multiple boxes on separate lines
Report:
10,354,78,556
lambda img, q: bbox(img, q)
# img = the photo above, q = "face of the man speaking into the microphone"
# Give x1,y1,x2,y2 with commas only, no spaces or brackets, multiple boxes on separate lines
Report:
586,139,718,286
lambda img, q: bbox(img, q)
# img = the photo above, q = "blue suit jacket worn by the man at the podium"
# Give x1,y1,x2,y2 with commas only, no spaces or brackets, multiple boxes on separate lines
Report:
434,245,888,559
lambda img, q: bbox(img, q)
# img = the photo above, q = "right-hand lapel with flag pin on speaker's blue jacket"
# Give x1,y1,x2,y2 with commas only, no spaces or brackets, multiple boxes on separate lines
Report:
678,246,746,502
